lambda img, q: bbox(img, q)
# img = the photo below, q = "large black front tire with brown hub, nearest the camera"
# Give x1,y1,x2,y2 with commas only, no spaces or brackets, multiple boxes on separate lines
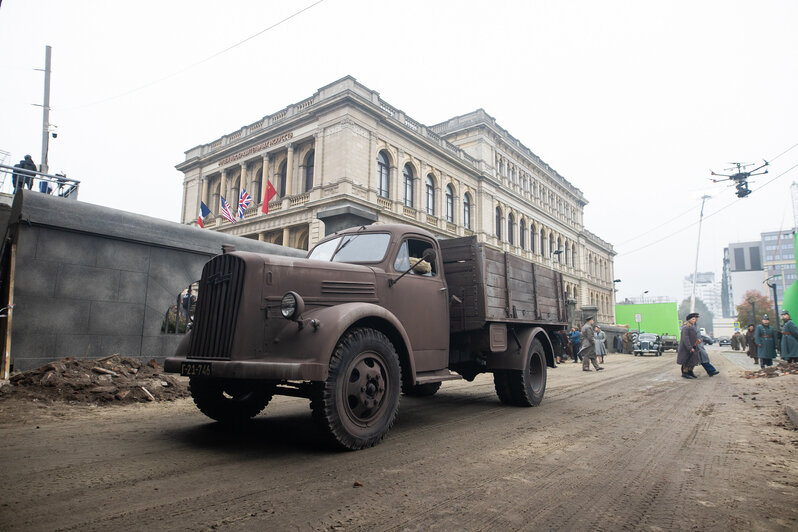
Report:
310,328,402,451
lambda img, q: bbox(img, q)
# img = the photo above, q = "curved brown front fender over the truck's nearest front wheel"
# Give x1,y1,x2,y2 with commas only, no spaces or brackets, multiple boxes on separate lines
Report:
267,302,416,379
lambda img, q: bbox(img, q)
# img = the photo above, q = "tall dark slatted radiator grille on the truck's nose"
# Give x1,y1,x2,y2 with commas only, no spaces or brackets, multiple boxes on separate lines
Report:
188,255,244,359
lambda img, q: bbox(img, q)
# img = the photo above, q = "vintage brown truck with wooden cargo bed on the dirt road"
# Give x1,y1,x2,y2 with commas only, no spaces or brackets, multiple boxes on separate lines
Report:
165,225,567,449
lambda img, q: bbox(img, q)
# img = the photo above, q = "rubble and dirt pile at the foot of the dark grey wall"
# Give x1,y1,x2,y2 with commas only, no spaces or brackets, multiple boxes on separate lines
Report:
0,355,189,404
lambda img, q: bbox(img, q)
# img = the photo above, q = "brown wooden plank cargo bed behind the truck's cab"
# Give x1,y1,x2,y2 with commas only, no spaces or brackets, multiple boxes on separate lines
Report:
440,236,567,332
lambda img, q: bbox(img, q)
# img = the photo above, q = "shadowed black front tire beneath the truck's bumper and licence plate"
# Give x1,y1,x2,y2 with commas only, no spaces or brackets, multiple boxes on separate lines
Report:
189,377,273,423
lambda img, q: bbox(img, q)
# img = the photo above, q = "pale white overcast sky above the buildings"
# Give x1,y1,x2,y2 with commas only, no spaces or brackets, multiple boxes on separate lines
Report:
0,0,798,301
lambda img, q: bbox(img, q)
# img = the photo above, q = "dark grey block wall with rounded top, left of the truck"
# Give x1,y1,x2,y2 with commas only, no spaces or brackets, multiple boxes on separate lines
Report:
0,190,306,376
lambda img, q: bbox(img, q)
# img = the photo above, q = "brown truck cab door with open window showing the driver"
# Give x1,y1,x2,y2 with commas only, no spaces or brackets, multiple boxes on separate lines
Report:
388,237,449,372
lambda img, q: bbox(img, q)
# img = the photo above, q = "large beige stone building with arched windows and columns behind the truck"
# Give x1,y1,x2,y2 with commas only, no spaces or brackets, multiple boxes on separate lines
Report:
177,76,615,323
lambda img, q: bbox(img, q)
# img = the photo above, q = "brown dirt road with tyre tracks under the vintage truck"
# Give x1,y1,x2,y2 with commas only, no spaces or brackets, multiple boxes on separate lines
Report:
0,351,798,531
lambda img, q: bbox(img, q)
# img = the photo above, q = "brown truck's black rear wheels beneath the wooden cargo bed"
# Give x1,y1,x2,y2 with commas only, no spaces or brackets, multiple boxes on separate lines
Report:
493,340,546,406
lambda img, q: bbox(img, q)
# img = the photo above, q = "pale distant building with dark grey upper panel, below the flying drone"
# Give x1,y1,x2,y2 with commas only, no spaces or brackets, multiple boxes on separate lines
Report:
721,242,767,310
